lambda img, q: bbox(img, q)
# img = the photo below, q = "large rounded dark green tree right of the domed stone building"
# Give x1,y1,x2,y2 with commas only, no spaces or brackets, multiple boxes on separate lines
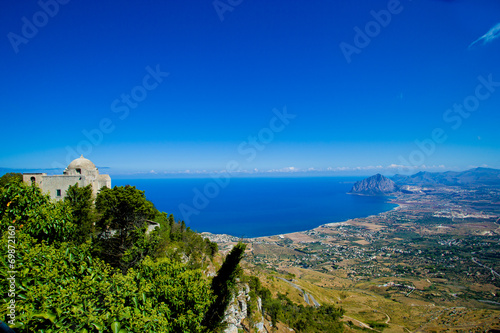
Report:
95,185,157,273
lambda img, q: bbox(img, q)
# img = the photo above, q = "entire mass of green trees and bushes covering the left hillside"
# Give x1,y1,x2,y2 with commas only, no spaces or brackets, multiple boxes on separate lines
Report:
0,182,223,333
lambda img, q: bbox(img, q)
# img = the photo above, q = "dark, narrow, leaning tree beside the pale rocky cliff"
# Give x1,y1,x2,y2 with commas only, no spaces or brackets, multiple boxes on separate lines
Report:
203,242,246,332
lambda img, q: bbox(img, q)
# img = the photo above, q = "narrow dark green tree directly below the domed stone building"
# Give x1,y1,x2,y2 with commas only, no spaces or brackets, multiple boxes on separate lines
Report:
64,184,94,243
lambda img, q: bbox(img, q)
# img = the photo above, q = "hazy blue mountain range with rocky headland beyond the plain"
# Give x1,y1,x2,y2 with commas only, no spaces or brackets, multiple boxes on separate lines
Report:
349,168,500,195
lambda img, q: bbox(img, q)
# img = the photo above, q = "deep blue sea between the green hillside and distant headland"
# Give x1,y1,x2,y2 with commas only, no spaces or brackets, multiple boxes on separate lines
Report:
113,177,396,237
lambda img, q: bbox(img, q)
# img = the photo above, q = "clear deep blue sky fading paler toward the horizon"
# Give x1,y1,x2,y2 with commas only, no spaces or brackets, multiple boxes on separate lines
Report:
0,0,500,174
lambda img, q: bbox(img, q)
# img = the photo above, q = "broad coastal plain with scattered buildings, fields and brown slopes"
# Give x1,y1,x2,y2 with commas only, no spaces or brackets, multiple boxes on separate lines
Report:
205,185,500,332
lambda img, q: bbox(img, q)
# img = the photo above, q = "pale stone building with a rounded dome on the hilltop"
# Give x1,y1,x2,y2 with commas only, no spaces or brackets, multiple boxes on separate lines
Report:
23,155,111,200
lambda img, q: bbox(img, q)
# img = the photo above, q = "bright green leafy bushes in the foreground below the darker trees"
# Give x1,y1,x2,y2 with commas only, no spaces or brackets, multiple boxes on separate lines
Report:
1,234,211,332
